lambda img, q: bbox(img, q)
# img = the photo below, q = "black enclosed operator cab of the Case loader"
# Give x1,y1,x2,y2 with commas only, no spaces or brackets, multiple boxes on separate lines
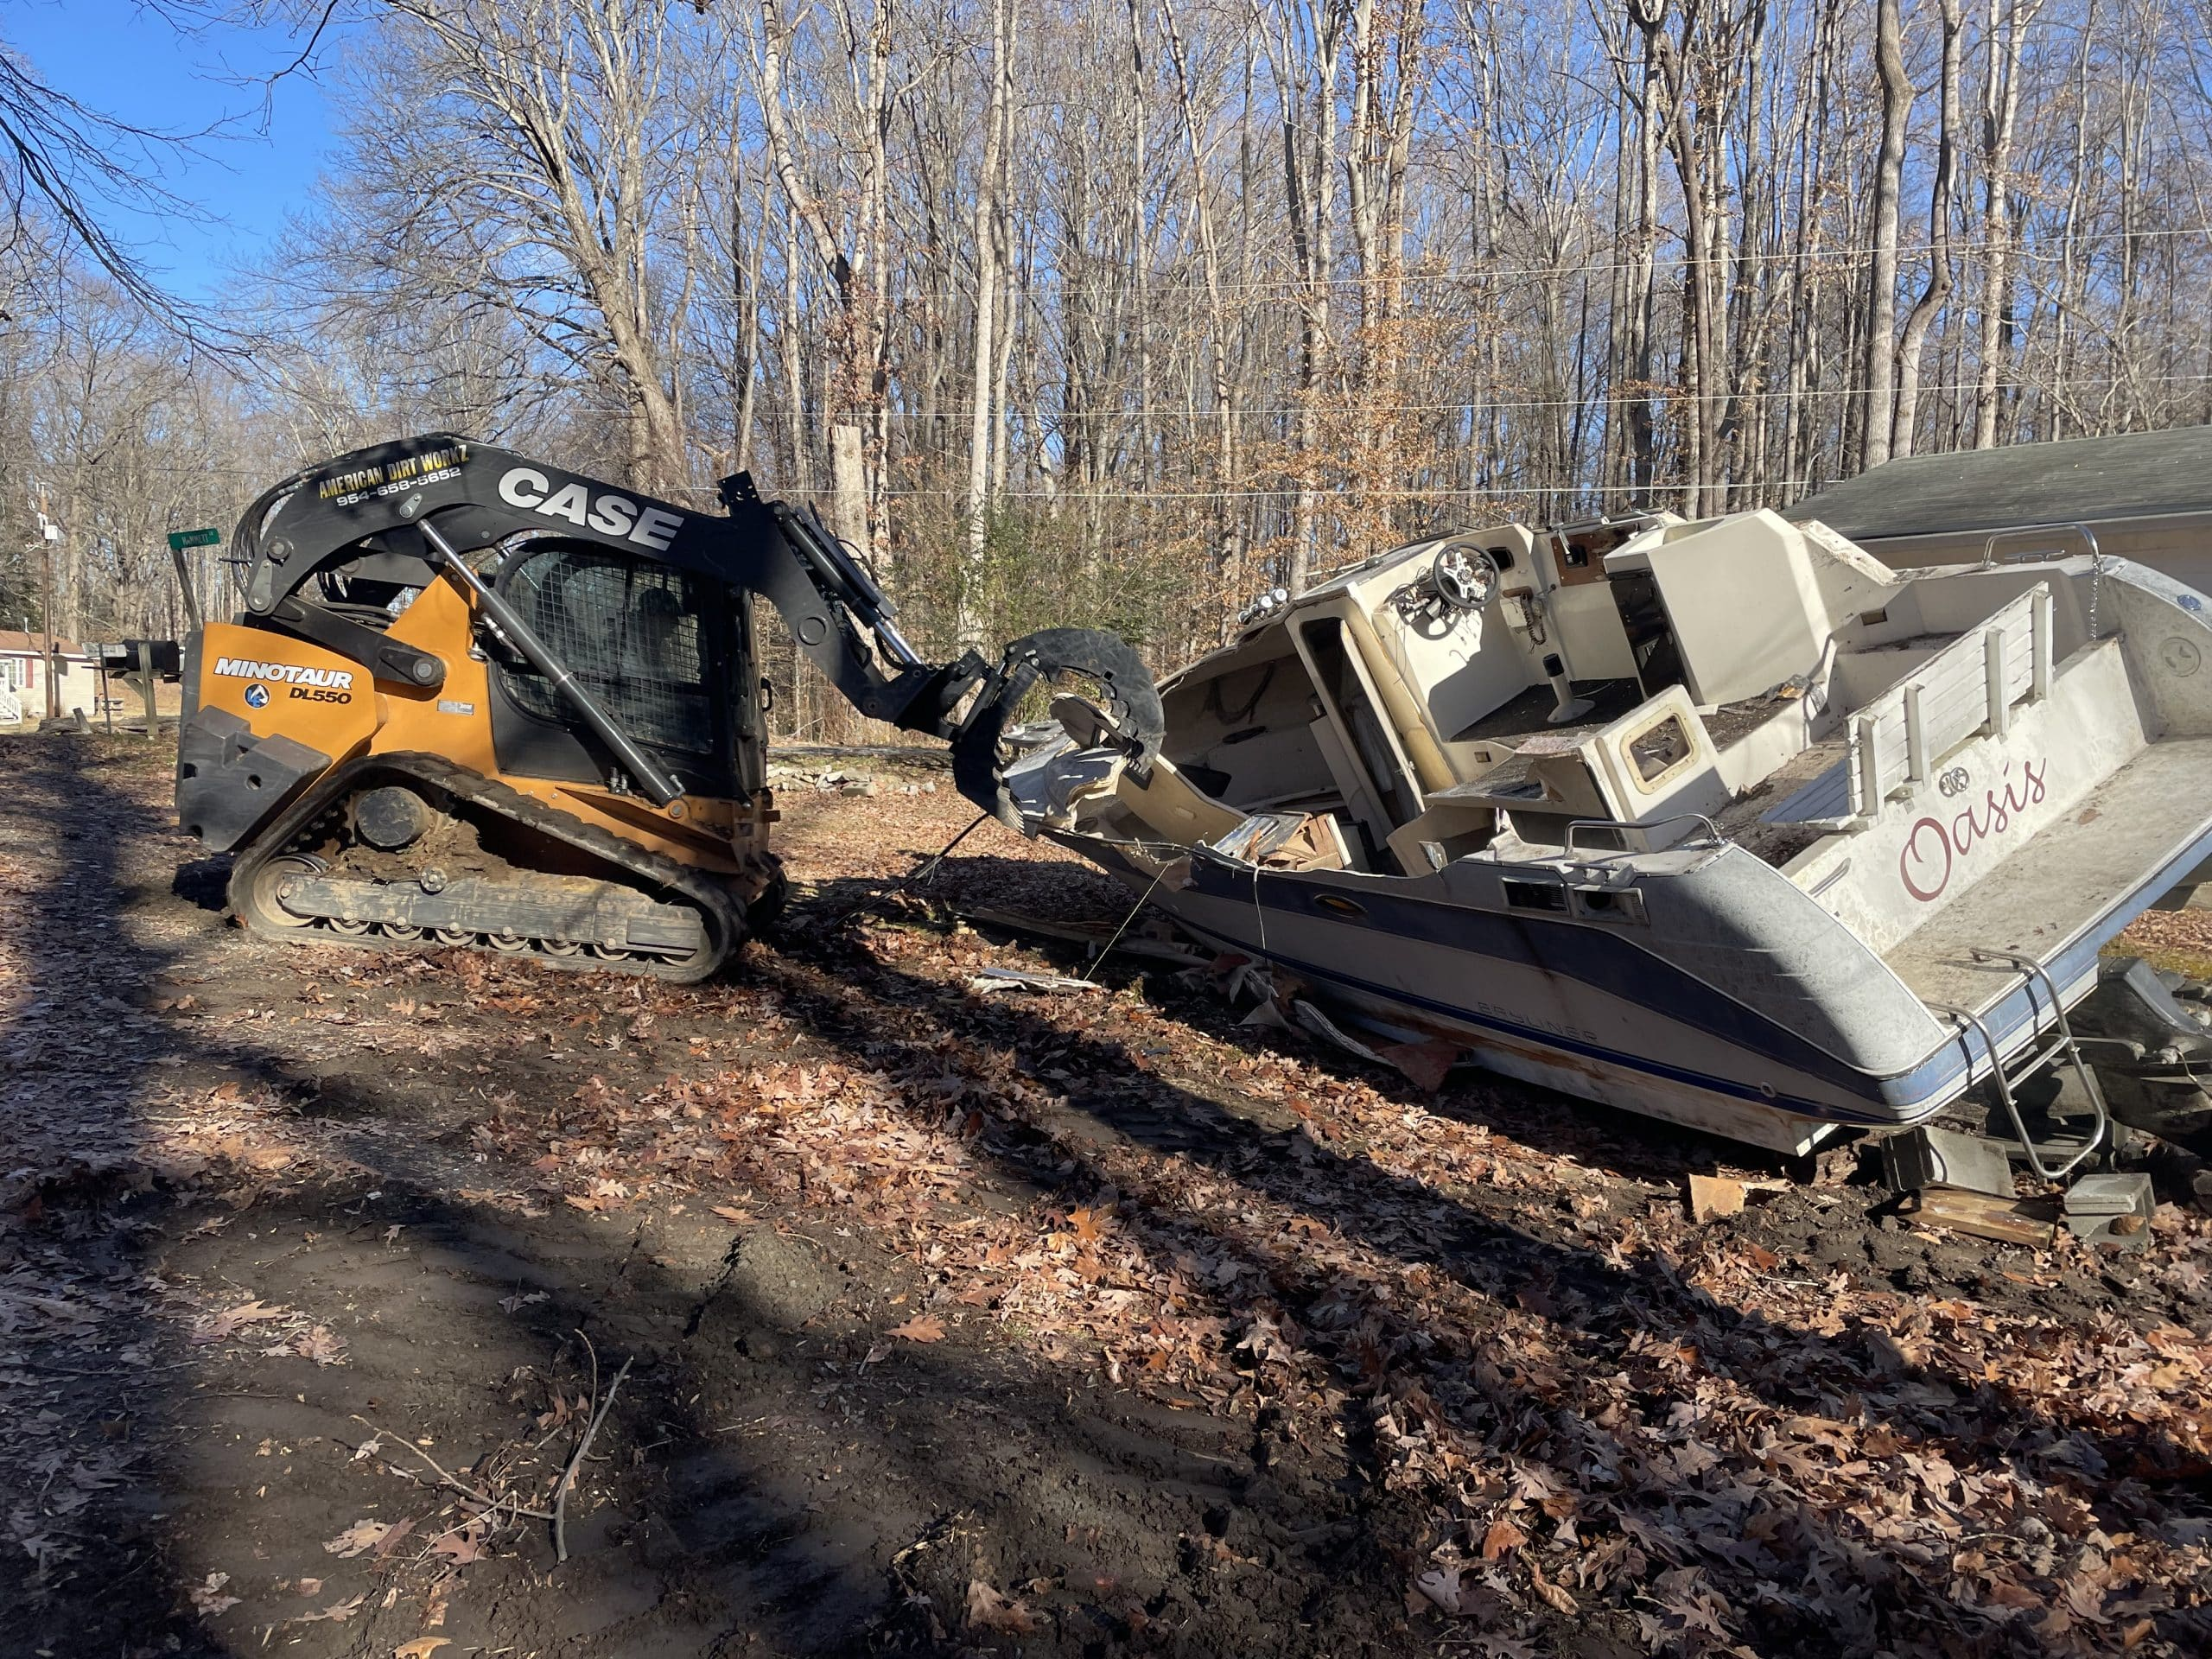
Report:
486,537,763,797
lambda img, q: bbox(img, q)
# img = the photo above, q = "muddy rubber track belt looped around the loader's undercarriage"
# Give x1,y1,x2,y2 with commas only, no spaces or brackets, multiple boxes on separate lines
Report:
228,750,756,984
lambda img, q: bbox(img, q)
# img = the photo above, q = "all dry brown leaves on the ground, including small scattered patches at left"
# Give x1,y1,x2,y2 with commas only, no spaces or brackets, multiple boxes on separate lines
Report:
0,743,2212,1655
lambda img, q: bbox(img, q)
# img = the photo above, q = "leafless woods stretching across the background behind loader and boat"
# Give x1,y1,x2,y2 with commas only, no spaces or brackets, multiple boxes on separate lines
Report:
0,0,2212,721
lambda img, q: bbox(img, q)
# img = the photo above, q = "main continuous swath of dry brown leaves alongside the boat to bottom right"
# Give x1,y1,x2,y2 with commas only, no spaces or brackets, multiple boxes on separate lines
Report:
422,875,2212,1652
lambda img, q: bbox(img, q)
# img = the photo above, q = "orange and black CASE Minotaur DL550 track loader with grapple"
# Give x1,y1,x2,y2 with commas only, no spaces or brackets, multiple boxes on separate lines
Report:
177,434,1161,980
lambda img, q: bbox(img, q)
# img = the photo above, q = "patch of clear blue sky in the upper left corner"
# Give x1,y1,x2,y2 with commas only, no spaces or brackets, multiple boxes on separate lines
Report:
0,0,349,299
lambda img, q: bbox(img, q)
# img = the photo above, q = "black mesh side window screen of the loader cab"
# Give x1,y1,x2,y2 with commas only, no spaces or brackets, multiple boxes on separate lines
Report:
500,549,715,754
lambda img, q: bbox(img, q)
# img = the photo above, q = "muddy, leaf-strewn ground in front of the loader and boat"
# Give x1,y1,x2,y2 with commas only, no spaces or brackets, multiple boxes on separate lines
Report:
0,736,2212,1659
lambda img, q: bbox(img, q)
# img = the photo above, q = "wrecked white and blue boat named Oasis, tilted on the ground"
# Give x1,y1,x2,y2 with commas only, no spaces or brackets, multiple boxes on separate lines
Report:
1007,511,2212,1177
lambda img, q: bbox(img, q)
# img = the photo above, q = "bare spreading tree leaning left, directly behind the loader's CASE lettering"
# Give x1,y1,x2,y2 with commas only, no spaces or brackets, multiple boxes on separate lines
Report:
325,0,690,493
